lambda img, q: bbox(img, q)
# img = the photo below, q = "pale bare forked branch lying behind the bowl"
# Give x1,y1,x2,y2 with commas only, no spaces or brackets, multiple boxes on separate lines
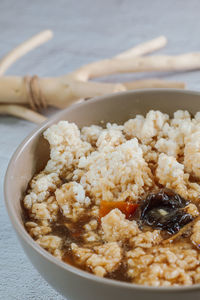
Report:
0,30,200,123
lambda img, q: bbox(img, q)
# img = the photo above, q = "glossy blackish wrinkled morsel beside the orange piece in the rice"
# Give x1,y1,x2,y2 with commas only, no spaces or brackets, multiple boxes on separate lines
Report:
141,189,193,234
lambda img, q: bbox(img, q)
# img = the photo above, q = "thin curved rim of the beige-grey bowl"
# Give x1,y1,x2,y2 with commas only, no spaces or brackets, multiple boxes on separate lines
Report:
4,88,200,292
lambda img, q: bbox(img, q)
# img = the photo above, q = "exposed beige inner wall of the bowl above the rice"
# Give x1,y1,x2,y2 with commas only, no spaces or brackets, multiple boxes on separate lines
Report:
5,89,200,290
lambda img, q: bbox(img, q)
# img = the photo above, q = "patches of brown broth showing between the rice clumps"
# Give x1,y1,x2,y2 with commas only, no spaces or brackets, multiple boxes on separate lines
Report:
21,178,200,282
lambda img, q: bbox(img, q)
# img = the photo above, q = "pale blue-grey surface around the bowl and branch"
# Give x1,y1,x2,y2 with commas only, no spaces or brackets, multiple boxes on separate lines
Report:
0,0,200,300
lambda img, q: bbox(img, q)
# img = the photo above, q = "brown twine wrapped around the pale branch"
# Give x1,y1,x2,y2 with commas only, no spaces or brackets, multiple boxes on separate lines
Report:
24,75,47,111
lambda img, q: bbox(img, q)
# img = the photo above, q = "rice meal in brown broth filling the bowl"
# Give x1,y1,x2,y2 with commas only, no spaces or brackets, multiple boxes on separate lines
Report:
22,110,200,286
